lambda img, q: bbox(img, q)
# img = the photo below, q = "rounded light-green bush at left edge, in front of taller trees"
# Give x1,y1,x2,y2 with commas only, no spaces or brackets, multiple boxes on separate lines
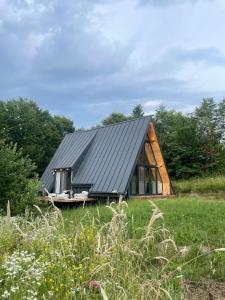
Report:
0,140,38,213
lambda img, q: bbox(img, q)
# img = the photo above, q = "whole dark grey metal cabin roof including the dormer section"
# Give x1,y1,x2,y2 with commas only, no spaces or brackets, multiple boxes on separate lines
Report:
42,116,151,194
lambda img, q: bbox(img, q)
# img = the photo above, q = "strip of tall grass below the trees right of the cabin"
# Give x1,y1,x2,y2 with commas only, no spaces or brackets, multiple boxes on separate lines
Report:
173,176,225,193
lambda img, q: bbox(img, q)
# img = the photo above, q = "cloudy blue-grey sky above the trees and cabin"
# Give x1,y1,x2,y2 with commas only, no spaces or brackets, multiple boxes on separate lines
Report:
0,0,225,128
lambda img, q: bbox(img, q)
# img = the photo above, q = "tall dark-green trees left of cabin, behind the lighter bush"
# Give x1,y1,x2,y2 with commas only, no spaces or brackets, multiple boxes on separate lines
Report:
0,98,74,174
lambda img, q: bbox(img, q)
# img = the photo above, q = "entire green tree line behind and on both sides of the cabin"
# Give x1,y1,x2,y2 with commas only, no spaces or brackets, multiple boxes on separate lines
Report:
0,98,225,212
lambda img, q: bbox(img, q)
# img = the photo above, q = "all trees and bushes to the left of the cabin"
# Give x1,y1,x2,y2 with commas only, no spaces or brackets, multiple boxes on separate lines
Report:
0,98,75,214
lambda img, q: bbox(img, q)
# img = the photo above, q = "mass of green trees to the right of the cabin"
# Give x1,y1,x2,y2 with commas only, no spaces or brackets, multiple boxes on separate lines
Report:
154,99,225,179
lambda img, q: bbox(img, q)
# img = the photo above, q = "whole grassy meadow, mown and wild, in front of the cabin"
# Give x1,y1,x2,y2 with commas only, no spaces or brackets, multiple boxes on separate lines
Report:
0,195,225,300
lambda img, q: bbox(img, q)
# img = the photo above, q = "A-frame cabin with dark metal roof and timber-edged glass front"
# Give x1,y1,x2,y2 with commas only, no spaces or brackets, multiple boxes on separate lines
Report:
41,116,172,198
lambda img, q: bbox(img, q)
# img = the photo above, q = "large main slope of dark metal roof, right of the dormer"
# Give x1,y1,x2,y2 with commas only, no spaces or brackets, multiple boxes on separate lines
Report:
73,117,150,193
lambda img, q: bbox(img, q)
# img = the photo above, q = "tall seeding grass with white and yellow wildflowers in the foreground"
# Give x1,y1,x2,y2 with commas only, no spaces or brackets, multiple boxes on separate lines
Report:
0,201,184,300
